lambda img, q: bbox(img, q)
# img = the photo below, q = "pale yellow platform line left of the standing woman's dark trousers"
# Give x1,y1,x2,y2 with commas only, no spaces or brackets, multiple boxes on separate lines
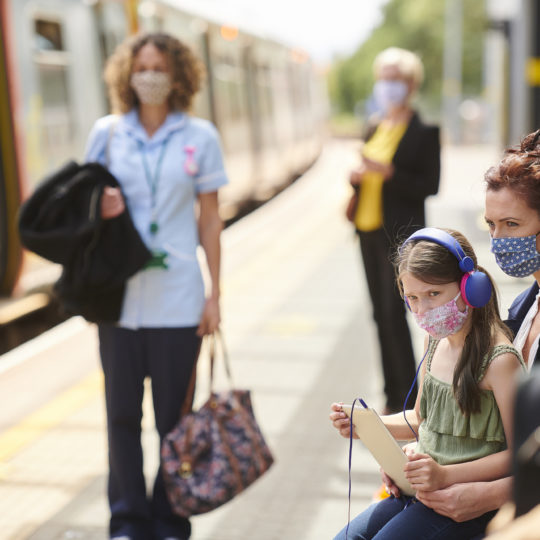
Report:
0,370,103,464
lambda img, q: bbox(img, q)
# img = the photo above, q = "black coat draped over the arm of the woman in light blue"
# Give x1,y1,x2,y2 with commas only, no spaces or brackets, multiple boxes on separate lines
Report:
19,161,151,322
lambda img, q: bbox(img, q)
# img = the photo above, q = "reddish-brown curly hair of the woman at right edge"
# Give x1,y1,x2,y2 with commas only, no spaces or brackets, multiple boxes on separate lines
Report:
484,129,540,216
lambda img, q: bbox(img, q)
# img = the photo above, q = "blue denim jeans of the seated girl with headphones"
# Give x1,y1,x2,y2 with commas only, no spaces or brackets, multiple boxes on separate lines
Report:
334,497,495,540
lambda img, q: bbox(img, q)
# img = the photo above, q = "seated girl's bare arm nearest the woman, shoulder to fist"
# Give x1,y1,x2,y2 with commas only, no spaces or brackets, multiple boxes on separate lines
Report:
405,353,522,491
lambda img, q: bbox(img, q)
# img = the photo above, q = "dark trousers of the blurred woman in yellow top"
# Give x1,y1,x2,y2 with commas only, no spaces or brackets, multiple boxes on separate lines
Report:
358,229,417,412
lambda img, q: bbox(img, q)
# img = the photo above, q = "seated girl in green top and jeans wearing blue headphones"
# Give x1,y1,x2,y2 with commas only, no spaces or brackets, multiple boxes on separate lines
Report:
330,228,524,540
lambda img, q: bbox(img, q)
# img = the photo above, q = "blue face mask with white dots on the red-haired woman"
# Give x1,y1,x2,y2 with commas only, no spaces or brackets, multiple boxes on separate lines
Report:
491,233,540,277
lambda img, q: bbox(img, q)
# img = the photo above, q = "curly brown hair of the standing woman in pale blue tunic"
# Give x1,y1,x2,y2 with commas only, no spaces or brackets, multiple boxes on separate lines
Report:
104,33,205,113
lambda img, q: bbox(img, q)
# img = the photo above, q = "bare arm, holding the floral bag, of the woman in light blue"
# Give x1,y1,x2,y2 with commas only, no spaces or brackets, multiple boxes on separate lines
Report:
197,191,223,336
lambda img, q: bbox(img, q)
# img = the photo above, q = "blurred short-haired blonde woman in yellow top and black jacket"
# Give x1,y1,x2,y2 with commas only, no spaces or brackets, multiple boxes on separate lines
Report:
348,47,440,414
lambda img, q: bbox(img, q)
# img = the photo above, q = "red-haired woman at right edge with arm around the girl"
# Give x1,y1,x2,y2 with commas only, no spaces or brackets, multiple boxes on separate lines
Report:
420,130,540,538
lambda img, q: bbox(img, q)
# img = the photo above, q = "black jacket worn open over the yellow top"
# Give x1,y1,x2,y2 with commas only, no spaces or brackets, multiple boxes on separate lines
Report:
360,113,441,239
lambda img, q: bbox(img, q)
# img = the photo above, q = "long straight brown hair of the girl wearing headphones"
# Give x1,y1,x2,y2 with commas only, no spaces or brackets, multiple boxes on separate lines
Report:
395,229,511,415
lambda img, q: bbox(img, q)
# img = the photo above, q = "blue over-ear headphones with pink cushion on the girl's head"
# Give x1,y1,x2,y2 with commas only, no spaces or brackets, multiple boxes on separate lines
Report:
402,227,493,308
